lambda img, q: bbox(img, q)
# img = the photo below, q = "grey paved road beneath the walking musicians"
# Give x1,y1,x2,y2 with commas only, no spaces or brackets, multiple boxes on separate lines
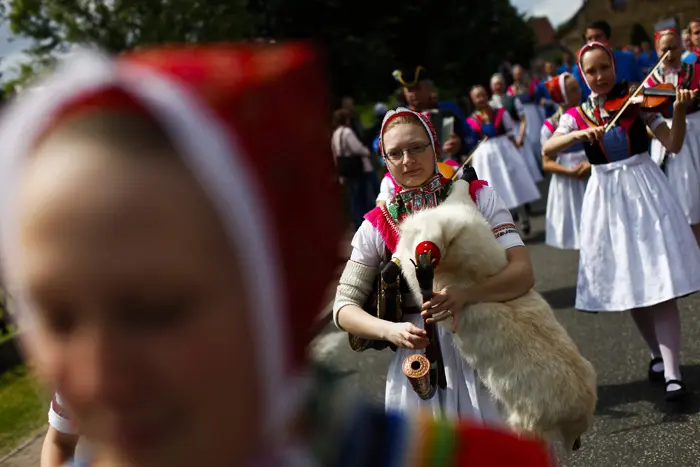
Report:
314,183,700,467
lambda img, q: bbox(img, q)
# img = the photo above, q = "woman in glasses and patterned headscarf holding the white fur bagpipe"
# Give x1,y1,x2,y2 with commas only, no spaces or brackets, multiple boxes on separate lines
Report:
333,108,534,423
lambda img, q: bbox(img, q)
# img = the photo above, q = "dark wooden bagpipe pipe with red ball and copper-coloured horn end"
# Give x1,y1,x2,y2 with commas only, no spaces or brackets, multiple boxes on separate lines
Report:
402,242,447,400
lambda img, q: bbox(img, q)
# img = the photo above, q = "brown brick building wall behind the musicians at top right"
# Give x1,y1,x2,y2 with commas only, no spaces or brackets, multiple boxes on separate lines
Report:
559,0,700,52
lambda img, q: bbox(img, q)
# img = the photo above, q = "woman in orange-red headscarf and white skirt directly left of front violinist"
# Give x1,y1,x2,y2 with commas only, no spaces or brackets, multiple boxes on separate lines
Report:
540,73,591,250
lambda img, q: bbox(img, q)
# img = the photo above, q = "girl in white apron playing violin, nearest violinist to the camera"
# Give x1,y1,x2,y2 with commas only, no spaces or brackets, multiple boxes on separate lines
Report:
544,42,700,401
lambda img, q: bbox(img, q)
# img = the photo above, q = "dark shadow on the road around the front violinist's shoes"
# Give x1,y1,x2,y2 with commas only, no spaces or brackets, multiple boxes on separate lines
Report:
596,365,700,423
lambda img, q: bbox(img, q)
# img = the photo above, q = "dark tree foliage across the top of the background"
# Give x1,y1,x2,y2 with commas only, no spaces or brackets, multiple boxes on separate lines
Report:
0,0,534,99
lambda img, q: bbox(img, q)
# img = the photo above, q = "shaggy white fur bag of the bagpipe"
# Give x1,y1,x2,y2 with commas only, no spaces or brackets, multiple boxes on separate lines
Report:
395,180,596,451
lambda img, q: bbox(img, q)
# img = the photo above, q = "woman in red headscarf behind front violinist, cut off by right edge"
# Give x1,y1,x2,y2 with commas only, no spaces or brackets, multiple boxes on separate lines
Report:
644,29,700,242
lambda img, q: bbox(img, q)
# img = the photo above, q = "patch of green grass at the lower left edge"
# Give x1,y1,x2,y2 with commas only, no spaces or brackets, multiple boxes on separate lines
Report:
0,365,49,457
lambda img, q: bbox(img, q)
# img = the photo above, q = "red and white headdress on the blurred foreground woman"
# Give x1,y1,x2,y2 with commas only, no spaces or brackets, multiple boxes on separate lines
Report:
0,44,341,444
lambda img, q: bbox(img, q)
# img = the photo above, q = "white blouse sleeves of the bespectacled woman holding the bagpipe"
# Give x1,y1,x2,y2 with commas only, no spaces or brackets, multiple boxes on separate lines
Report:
350,186,525,268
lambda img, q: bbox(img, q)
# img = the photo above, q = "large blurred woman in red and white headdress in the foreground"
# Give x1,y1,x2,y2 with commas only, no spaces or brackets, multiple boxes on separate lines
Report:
0,45,544,467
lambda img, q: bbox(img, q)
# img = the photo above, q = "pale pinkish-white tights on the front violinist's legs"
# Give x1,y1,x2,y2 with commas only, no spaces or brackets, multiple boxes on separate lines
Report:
632,300,681,390
